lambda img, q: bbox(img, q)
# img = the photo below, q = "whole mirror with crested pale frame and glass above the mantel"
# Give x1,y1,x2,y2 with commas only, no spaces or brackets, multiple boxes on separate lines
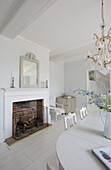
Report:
20,53,39,88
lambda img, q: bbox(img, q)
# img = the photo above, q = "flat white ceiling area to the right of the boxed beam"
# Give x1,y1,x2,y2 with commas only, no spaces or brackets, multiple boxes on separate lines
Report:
21,0,111,57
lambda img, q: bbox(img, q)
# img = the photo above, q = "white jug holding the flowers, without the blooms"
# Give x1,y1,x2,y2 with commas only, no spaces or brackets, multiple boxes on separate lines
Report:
100,110,111,140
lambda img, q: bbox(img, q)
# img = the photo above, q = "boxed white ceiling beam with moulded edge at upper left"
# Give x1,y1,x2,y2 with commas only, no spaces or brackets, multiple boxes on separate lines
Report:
0,0,57,39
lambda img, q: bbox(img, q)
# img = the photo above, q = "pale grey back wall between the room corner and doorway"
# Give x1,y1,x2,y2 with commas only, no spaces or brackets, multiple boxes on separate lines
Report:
64,60,86,109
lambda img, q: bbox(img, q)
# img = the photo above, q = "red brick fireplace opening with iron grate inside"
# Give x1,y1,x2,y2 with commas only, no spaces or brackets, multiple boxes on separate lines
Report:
12,99,48,140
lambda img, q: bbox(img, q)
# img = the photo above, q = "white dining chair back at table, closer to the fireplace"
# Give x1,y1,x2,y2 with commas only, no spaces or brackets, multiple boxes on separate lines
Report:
64,113,77,129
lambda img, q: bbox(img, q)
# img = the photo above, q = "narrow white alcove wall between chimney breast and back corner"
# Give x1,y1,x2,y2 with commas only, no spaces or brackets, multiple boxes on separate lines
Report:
50,61,64,97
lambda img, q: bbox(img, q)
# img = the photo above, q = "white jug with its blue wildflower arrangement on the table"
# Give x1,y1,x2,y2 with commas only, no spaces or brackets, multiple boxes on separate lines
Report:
72,89,111,139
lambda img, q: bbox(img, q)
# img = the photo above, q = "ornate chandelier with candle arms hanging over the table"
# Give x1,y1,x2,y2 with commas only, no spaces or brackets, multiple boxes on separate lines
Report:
86,0,111,69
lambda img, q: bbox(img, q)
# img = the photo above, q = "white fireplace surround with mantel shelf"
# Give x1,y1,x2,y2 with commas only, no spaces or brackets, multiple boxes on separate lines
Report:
2,88,50,140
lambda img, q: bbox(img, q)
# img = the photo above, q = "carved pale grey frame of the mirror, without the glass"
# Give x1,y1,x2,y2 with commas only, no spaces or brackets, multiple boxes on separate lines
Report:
19,53,39,88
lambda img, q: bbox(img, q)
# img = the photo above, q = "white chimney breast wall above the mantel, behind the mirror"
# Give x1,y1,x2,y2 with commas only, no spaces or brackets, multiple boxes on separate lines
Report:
0,35,49,142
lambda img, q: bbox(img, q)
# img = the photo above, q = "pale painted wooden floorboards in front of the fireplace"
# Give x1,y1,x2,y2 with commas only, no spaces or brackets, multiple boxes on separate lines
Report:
0,117,64,170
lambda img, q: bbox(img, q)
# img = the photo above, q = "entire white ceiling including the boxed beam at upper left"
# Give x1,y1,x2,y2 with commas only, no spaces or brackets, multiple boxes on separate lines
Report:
0,0,111,61
